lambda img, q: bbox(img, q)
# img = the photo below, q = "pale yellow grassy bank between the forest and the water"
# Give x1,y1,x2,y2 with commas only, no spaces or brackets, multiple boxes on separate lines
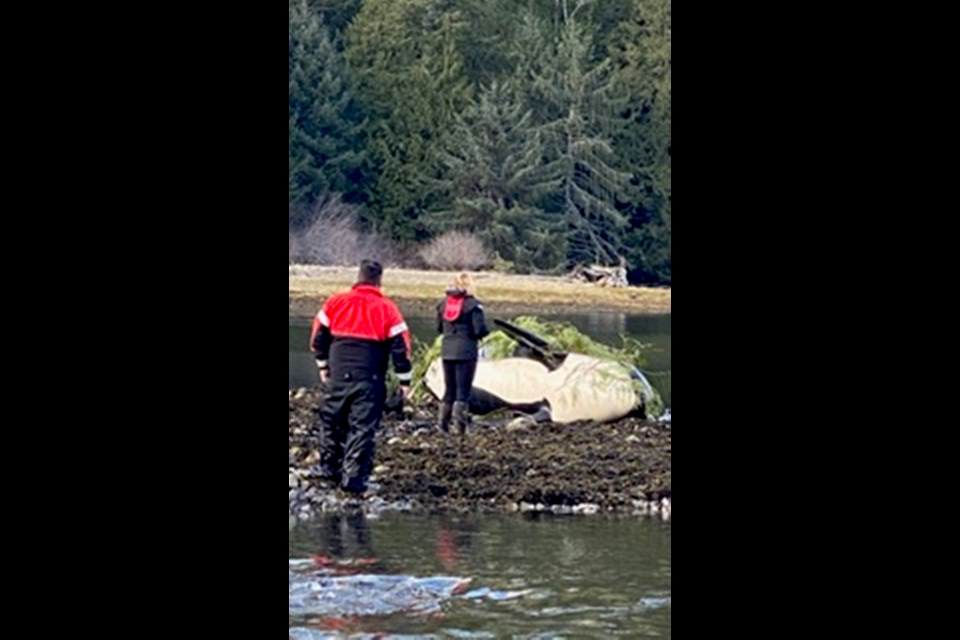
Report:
289,266,671,317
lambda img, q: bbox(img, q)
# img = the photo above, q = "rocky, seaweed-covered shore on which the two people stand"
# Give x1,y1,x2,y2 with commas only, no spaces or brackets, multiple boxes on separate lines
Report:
288,388,672,520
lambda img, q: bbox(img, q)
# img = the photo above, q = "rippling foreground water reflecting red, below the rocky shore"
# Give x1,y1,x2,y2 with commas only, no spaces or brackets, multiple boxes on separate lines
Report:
289,513,671,638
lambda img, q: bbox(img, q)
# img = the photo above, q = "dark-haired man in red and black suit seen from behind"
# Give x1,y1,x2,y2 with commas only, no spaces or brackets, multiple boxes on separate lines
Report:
310,260,413,494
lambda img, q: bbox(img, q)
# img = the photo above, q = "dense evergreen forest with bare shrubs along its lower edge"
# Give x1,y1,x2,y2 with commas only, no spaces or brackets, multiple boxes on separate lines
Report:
288,0,671,286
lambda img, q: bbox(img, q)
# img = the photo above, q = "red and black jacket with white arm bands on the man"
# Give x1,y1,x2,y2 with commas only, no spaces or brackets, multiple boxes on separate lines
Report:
310,284,413,384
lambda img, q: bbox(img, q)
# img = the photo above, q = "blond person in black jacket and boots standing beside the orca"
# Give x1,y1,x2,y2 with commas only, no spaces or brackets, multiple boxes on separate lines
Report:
437,273,490,435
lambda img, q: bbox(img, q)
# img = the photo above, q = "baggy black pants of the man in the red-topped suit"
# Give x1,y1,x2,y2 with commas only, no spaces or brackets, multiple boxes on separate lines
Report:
320,380,386,492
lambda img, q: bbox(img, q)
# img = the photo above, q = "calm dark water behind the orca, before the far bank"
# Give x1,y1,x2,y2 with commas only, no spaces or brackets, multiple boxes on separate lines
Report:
289,311,672,407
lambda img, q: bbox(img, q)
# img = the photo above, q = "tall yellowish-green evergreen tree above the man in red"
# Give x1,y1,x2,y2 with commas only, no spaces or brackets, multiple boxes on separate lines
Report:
346,0,470,242
